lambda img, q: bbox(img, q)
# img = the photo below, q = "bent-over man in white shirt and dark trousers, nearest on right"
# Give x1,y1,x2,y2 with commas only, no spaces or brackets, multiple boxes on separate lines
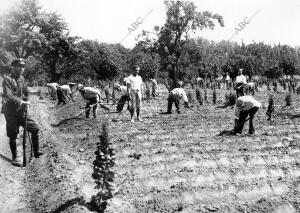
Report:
234,96,262,134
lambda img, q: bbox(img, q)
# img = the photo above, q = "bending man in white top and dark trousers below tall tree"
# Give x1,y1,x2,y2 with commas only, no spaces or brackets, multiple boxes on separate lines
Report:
167,82,189,114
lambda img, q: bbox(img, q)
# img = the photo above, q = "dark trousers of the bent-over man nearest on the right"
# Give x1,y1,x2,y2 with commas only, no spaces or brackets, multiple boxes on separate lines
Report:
235,107,258,134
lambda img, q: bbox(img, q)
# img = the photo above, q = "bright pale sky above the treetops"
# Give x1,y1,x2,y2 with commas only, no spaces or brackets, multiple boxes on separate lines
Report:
0,0,300,48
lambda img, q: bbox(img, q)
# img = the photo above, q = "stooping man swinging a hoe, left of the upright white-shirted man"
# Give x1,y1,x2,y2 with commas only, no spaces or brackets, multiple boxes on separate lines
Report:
77,84,101,118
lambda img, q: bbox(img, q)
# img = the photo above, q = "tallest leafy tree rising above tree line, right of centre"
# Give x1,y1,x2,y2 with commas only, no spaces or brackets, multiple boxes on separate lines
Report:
138,0,224,87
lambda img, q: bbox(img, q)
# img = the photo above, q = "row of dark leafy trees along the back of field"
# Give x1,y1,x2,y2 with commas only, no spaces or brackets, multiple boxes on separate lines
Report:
0,0,300,86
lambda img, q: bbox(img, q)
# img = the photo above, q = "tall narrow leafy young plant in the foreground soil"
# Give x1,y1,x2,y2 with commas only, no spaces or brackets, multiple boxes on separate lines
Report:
91,122,115,212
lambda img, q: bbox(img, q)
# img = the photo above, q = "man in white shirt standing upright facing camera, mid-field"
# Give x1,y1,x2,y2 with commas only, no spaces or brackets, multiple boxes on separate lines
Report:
127,65,143,123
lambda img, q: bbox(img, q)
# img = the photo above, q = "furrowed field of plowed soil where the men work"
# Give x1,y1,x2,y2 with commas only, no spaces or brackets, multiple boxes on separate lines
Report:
1,82,300,213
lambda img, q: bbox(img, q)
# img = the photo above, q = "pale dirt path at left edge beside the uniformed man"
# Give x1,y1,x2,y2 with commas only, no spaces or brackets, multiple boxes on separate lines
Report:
0,79,30,213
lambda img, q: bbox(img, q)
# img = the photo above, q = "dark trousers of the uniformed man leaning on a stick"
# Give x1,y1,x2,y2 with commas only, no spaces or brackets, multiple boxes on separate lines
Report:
4,114,41,159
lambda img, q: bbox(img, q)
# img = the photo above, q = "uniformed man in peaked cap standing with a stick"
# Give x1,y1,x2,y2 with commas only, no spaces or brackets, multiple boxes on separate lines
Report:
1,58,43,166
